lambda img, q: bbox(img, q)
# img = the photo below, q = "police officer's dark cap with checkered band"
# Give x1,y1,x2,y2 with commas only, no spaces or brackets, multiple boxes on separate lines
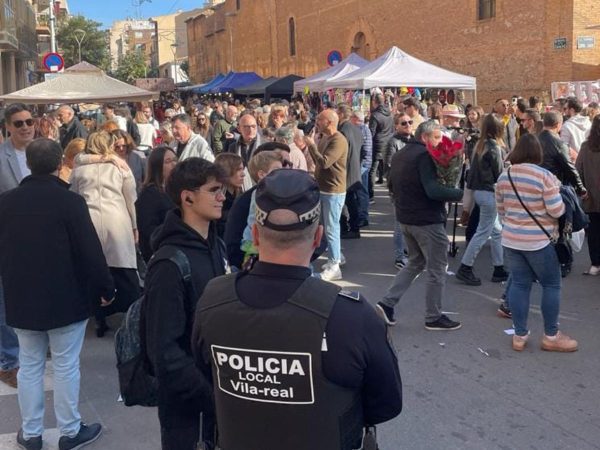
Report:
256,169,321,231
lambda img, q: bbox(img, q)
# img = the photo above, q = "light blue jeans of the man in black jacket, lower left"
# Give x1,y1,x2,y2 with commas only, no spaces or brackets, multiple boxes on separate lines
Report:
15,319,87,439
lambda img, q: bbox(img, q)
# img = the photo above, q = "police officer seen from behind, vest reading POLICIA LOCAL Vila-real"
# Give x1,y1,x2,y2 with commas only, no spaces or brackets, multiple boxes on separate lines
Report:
192,169,402,450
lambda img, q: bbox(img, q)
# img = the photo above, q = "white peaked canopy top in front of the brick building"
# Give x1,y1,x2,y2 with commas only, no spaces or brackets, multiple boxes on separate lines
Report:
323,47,477,91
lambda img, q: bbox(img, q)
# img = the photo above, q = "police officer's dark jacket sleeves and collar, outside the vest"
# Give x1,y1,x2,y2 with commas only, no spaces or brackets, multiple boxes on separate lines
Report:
192,262,402,425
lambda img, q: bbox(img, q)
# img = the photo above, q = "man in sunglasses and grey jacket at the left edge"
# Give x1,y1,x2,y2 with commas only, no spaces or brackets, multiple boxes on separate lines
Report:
0,103,35,388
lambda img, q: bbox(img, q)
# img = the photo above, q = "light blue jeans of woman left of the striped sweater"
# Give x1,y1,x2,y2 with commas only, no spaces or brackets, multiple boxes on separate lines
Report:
461,191,504,267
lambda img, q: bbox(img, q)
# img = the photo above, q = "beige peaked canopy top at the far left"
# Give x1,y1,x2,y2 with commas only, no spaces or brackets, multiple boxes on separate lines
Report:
0,62,158,105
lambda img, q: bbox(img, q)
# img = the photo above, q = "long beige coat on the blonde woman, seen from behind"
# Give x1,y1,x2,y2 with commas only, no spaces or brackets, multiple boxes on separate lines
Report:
71,163,137,269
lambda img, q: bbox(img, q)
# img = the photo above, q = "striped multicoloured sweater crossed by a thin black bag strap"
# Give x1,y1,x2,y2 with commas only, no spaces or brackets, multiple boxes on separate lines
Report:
496,164,565,251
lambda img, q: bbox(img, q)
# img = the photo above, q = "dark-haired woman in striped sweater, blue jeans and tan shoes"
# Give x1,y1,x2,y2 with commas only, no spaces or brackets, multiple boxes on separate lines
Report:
496,134,577,352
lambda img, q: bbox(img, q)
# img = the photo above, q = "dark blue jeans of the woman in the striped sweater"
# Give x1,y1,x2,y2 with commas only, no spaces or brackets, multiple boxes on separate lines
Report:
504,245,561,336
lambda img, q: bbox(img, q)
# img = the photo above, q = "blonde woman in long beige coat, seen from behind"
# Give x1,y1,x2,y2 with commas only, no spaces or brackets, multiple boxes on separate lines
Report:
71,131,140,337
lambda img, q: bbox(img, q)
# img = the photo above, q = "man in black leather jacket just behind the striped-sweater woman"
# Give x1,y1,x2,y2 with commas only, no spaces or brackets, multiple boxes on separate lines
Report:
538,111,587,197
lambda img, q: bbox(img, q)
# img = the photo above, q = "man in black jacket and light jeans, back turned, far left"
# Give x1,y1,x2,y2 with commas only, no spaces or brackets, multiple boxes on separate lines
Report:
0,139,115,449
